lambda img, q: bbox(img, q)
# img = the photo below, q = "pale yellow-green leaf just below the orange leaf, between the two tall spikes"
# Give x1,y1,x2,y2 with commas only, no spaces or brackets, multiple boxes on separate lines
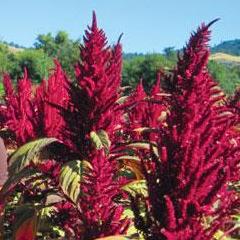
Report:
122,180,148,197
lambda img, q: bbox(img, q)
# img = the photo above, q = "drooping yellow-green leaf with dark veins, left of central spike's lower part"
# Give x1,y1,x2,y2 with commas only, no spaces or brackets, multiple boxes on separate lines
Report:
59,160,91,203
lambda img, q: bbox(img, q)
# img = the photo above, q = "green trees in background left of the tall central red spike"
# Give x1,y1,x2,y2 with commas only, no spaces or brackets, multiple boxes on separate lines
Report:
0,31,79,83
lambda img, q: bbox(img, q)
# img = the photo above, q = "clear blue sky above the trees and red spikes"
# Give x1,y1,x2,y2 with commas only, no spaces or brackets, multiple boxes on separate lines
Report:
0,0,240,53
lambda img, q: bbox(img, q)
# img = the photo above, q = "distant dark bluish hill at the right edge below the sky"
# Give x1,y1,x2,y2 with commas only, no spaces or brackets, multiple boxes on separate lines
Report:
212,39,240,56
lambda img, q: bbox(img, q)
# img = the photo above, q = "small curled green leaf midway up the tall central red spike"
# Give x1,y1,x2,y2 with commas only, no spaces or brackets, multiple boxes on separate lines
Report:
90,130,111,152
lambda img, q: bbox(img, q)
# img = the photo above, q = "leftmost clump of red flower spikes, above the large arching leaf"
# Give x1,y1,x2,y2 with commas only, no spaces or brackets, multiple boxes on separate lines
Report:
1,69,38,145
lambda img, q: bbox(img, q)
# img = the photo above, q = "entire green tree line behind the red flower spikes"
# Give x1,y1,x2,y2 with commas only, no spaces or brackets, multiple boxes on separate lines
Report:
0,31,240,94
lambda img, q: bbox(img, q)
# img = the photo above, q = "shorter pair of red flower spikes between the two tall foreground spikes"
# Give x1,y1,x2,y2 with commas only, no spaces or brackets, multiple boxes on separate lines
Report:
125,72,168,142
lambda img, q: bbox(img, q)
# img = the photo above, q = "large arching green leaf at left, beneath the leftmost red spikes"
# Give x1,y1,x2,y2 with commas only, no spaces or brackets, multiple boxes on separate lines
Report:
9,138,58,176
